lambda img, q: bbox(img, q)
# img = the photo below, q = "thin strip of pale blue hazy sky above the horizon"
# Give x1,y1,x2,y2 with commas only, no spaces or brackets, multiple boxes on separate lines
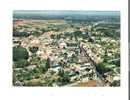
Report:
14,10,120,16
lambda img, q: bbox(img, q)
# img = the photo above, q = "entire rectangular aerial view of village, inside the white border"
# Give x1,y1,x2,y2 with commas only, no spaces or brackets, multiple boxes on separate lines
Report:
12,10,121,87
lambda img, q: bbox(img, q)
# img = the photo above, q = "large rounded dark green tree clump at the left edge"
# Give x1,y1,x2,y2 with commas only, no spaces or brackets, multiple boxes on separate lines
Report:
13,46,29,61
